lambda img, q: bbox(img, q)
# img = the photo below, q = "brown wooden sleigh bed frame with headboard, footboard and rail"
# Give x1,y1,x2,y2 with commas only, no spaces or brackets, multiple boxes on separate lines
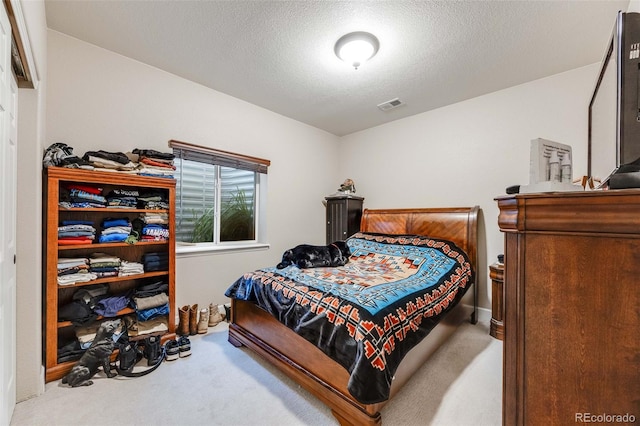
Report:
229,206,479,425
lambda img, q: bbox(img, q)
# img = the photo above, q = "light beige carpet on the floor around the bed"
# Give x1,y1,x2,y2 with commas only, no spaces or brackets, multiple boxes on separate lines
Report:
11,322,502,426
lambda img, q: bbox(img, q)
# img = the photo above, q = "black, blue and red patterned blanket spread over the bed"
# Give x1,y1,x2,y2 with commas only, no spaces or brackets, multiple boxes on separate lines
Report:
225,233,474,404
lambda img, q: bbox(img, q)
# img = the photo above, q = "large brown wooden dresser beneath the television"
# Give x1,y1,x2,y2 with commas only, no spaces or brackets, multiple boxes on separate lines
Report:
496,190,640,425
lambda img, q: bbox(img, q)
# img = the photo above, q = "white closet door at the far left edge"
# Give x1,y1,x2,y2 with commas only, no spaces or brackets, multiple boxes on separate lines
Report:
0,0,18,424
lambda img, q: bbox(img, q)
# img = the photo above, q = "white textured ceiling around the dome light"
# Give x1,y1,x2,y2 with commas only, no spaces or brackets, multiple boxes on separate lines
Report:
45,0,629,136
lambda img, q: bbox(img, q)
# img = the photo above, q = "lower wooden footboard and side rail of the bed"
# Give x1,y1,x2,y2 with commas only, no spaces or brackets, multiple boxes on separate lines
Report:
229,299,471,425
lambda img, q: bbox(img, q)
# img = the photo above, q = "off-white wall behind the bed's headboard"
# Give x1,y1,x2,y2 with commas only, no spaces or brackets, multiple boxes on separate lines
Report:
339,64,598,307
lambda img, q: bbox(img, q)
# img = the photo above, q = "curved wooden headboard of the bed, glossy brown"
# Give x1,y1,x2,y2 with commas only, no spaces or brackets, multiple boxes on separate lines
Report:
360,206,480,271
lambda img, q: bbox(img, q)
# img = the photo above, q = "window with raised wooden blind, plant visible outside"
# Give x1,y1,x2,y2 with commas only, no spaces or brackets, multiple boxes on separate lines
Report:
169,140,270,253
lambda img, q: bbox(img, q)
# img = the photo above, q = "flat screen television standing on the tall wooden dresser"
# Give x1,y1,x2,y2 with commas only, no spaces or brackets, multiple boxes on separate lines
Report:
587,12,640,185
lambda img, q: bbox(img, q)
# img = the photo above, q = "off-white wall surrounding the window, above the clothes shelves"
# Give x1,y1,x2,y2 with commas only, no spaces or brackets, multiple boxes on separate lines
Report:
47,31,343,312
